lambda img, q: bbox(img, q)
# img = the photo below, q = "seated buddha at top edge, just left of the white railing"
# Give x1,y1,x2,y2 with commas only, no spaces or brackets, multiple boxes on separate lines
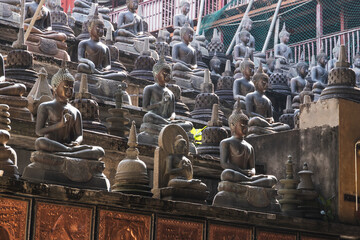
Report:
115,0,156,42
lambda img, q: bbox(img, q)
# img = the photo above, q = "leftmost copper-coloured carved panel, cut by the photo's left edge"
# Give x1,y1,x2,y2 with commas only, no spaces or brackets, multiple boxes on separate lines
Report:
0,197,29,240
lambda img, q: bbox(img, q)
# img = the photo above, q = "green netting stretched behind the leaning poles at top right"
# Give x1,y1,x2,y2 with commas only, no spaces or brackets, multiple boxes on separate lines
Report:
200,0,360,60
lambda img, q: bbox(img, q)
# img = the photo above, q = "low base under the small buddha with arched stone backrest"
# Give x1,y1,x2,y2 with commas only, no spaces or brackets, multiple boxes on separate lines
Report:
152,187,209,204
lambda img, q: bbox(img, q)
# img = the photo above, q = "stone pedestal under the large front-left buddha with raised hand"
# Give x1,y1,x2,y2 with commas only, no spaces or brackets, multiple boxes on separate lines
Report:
22,151,110,190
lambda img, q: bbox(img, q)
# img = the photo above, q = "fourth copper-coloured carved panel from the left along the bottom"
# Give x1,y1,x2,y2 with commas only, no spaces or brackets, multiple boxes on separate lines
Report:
156,218,204,240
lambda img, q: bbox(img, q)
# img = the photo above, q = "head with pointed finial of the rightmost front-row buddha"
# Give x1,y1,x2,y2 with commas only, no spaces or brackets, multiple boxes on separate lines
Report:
229,98,249,138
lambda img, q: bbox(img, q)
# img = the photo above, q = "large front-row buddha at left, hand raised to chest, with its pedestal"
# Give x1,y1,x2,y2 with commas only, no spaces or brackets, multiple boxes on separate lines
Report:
22,63,109,190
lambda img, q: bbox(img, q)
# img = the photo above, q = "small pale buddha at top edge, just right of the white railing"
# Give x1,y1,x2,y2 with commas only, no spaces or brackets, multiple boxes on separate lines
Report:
170,0,194,46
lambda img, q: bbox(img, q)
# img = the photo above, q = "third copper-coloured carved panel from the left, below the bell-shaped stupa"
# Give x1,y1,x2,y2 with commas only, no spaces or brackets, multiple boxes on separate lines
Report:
99,210,151,240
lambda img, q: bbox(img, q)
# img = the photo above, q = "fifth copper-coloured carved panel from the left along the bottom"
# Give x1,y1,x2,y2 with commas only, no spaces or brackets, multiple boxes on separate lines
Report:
209,224,252,240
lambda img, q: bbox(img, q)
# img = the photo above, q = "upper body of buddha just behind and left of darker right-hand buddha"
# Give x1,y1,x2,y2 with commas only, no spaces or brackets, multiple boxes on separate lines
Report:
233,55,255,102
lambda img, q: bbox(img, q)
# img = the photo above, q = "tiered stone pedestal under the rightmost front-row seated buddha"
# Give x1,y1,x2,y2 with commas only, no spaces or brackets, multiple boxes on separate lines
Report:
213,181,280,212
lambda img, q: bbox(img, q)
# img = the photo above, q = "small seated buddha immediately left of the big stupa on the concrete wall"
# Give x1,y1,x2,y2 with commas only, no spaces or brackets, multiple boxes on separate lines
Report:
310,51,328,101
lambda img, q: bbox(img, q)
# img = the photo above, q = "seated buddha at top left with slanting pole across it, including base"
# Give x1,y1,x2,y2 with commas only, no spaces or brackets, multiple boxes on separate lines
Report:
24,0,70,60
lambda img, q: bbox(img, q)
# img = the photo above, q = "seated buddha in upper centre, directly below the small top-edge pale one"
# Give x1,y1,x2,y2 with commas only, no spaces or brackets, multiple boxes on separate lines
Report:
172,23,204,89
